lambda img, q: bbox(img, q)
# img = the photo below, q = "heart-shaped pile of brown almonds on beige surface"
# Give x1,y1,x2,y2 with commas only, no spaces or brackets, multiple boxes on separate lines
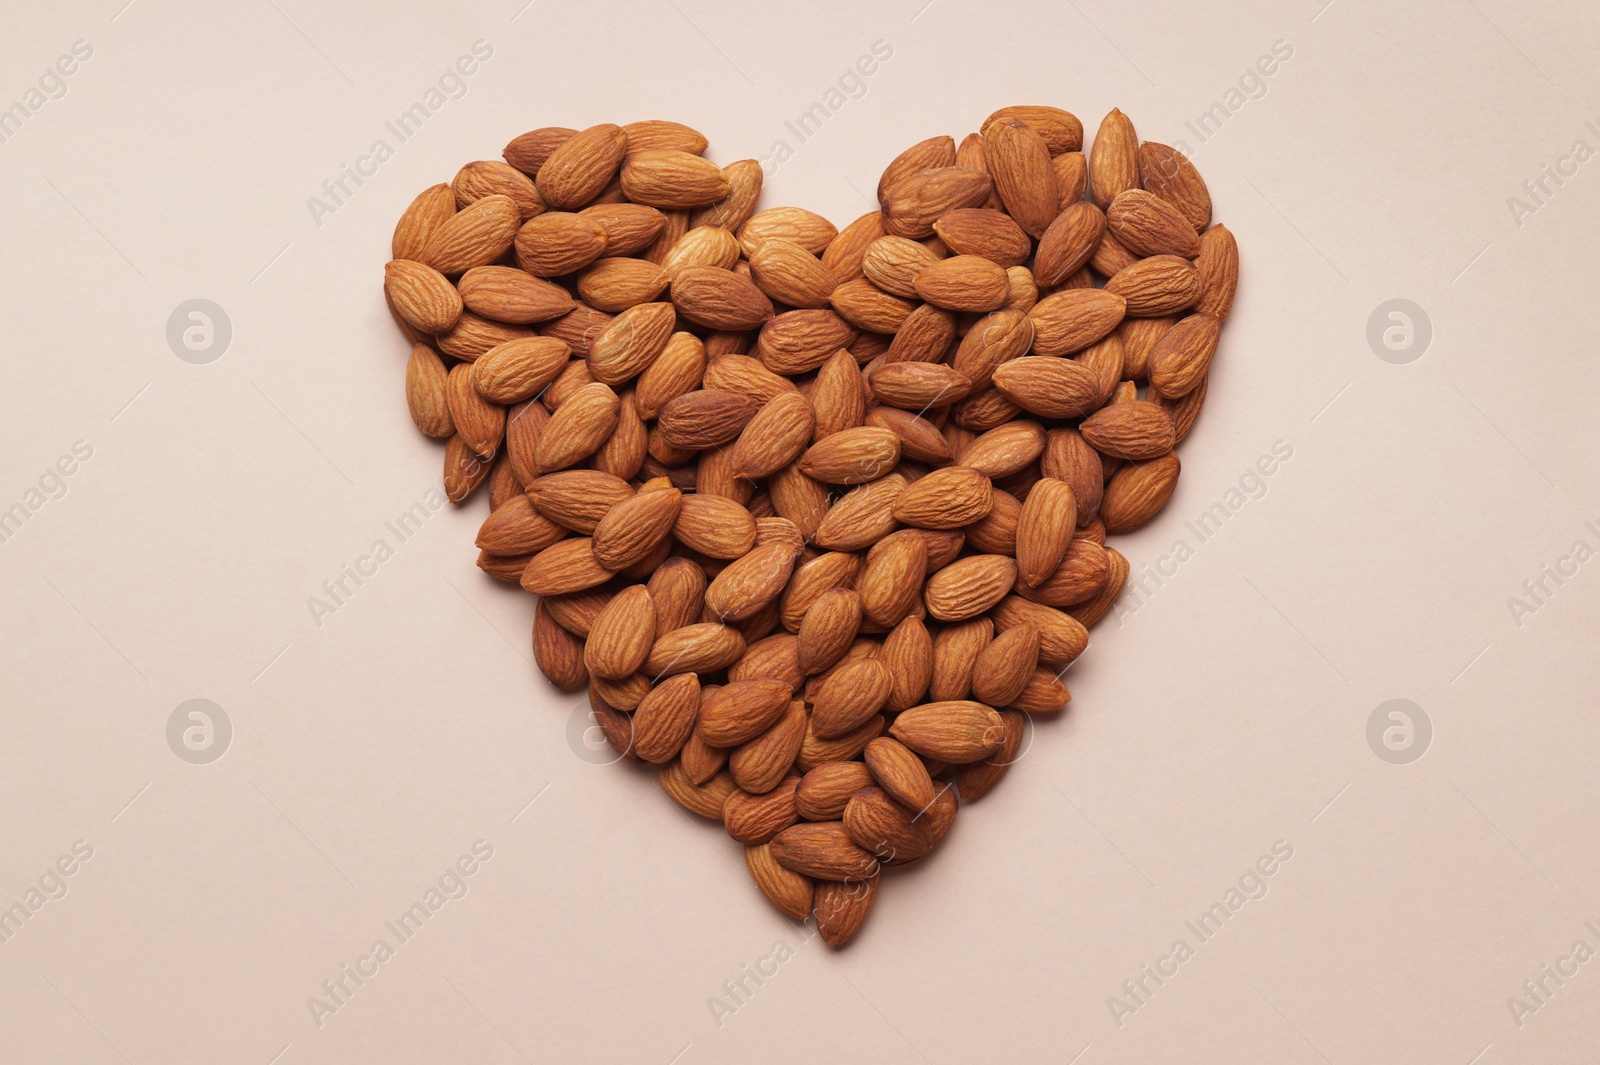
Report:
384,106,1238,947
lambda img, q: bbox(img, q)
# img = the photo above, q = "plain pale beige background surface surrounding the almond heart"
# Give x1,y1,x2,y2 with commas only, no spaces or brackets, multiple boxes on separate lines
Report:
0,0,1600,1065
